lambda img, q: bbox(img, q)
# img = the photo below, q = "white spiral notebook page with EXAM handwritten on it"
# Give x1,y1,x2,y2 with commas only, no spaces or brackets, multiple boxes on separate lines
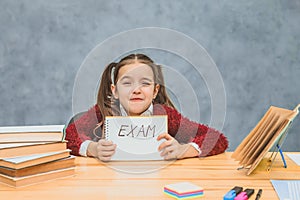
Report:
104,115,168,161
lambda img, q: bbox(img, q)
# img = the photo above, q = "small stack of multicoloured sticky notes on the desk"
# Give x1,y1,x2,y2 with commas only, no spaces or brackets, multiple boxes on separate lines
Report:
164,182,204,199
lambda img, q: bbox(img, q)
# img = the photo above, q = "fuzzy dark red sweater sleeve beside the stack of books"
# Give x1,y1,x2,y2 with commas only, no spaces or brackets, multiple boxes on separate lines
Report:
66,105,101,155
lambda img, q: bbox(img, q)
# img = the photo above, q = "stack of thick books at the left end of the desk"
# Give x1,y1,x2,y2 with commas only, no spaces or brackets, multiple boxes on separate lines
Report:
0,125,75,187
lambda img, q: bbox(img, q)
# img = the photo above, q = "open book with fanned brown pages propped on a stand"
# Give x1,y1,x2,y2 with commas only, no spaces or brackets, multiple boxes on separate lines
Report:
232,104,300,175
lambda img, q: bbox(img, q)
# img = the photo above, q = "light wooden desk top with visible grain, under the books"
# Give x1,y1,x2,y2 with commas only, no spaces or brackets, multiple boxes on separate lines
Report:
0,152,300,200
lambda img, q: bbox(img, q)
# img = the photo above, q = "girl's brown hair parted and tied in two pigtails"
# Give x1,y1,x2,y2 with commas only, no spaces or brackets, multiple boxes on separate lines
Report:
97,54,175,120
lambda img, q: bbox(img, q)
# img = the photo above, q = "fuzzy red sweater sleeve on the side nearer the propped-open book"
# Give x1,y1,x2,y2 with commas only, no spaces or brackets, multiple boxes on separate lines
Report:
155,106,228,157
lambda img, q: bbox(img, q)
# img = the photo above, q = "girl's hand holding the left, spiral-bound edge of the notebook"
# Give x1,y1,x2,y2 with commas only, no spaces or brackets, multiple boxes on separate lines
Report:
88,139,117,162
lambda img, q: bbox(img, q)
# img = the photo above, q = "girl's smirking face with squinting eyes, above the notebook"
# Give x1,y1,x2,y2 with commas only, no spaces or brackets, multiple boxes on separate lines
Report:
111,63,159,115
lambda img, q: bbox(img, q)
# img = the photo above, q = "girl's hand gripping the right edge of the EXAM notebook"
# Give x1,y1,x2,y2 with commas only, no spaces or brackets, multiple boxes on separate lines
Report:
157,133,190,160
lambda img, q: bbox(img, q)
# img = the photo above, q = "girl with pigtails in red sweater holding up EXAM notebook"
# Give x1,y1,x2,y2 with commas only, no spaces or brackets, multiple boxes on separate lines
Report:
66,54,228,161
